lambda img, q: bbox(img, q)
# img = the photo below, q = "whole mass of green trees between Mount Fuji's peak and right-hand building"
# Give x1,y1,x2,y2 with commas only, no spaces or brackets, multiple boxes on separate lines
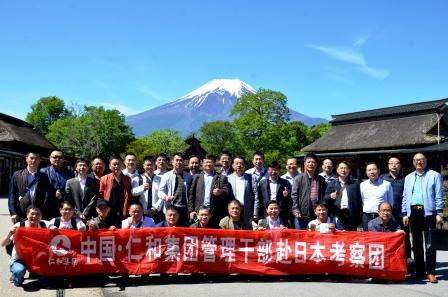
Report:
194,89,330,163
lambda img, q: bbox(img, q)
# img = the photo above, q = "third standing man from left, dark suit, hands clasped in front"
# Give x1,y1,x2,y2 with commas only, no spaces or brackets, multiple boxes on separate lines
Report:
65,159,100,222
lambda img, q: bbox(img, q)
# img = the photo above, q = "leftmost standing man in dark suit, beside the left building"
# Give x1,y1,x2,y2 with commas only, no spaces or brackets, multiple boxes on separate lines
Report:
8,152,48,224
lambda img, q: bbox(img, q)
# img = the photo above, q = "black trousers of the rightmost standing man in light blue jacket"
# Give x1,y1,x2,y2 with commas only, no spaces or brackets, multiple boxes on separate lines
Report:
409,207,436,274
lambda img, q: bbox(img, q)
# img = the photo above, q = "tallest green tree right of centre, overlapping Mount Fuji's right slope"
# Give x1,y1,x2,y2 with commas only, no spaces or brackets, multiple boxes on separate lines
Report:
230,89,290,156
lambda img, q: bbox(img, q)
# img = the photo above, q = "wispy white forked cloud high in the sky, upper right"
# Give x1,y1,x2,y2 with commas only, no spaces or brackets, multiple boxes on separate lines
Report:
307,35,390,80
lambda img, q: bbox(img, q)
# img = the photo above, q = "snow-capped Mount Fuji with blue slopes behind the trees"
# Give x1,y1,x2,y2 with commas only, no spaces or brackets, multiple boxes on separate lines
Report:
126,79,327,137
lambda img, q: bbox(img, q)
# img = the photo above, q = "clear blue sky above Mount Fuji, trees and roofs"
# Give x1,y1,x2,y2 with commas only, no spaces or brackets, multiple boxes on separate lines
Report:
0,0,448,119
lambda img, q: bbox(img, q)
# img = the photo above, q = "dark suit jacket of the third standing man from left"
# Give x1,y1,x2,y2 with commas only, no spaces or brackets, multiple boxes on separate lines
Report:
65,176,99,219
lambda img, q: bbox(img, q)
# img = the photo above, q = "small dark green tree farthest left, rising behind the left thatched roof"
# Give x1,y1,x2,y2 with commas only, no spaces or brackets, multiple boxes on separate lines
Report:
26,96,71,136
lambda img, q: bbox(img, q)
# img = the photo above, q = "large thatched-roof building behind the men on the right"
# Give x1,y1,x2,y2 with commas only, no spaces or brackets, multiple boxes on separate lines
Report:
303,98,448,177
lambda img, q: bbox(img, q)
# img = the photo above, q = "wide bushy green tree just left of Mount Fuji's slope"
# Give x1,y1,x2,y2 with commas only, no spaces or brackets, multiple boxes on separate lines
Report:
46,106,134,159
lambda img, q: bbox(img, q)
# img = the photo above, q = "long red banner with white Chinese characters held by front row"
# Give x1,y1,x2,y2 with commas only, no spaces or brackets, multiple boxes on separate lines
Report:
15,228,406,280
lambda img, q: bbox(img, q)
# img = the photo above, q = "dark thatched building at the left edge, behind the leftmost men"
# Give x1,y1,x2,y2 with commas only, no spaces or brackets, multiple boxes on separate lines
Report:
0,113,56,194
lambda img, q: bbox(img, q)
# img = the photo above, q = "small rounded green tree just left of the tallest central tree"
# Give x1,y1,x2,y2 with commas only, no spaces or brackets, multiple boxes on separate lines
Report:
199,121,238,156
